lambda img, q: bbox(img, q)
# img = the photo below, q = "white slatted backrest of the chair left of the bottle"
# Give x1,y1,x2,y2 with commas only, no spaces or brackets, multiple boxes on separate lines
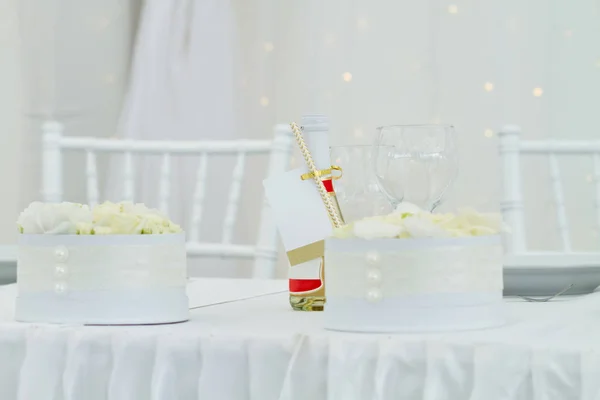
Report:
42,121,293,278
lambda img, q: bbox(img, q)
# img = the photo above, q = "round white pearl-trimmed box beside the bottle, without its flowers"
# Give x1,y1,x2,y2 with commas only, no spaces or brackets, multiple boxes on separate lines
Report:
324,236,505,332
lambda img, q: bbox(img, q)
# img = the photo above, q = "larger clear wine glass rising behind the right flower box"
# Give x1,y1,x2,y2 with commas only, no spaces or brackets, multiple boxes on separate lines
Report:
373,125,458,211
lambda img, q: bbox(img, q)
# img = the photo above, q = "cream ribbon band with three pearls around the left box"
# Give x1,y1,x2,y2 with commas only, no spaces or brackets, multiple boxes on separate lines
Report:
17,235,187,293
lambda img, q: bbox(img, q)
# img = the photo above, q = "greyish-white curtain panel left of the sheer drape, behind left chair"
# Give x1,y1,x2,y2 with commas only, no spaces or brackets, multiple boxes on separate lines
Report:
16,0,139,212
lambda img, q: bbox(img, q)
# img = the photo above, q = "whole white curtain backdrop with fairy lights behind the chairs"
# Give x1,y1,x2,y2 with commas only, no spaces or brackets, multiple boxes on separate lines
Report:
4,0,600,260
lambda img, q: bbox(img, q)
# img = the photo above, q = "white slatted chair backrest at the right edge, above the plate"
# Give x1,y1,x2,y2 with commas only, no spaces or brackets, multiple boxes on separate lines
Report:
499,125,600,254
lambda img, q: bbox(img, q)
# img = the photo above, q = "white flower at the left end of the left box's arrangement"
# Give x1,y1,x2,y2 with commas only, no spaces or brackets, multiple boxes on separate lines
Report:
17,202,92,235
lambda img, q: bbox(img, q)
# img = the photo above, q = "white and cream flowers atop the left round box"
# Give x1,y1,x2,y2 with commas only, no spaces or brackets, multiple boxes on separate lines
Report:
17,202,182,235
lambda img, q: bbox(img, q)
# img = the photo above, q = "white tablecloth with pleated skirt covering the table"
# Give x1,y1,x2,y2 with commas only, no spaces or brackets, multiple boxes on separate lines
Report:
0,280,600,400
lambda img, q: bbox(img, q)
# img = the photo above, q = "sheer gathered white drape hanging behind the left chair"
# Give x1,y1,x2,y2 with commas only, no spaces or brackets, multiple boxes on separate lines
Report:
109,0,235,230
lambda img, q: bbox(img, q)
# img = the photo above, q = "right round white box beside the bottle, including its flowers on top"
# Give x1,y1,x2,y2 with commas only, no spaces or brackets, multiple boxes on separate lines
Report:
325,204,505,332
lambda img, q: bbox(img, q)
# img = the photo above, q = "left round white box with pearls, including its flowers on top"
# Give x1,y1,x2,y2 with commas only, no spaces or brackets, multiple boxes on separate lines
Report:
15,202,189,325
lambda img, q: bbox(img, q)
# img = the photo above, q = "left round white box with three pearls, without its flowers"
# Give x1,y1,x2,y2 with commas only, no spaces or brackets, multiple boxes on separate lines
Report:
15,234,189,325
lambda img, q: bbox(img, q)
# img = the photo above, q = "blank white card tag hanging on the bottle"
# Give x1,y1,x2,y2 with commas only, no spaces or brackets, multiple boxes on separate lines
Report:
263,168,333,252
